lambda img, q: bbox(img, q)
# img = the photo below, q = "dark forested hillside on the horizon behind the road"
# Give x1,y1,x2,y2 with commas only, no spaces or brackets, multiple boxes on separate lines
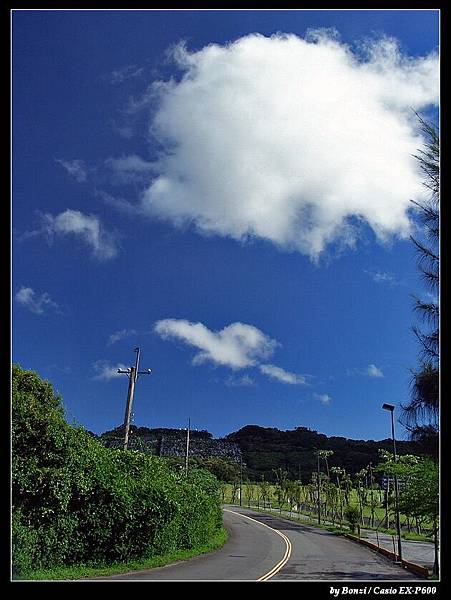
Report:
99,425,433,481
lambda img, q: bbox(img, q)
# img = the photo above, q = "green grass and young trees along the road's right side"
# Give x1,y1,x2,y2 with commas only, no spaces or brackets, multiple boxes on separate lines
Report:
221,450,439,541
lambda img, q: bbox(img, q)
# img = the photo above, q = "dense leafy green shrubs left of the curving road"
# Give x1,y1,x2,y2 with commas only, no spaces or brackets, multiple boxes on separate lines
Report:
12,365,222,576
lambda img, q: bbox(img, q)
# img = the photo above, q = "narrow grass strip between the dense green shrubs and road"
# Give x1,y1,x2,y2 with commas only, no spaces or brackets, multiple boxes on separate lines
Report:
16,528,229,581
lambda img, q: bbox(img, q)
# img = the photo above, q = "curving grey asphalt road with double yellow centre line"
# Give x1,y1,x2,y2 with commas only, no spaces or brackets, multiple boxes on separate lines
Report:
90,507,426,581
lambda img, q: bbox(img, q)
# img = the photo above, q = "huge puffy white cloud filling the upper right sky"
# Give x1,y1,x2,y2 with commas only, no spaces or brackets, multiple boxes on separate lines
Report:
137,32,438,260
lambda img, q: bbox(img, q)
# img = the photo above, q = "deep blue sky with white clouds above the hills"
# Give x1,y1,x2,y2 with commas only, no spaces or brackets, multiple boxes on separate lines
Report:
12,10,438,439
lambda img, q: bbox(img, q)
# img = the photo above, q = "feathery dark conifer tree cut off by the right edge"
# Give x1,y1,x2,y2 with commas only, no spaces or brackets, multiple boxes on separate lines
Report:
402,115,440,446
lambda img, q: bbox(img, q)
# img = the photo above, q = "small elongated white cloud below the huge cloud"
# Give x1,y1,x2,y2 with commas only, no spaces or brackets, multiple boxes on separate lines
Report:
154,319,277,369
